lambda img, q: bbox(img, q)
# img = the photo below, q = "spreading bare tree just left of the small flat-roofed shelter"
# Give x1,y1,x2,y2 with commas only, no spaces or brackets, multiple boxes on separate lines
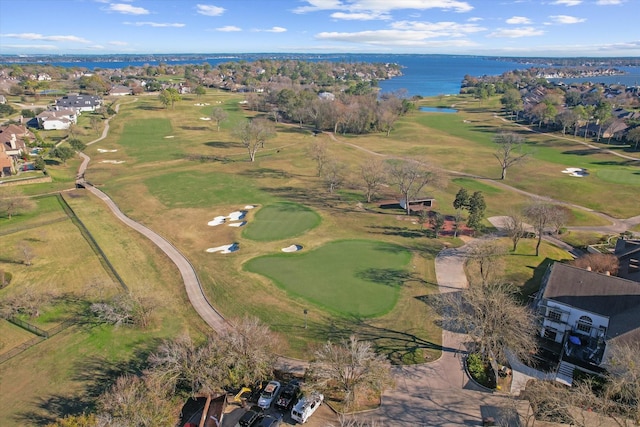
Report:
387,160,445,215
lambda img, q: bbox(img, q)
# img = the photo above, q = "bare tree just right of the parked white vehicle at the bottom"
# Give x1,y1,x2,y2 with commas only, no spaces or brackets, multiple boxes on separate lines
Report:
309,335,392,408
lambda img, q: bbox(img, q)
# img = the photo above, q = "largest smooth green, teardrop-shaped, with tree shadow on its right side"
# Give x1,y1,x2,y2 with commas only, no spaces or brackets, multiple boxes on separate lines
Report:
245,240,411,317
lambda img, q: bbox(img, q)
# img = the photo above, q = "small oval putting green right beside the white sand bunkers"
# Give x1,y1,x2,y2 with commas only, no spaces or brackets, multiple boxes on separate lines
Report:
242,203,320,242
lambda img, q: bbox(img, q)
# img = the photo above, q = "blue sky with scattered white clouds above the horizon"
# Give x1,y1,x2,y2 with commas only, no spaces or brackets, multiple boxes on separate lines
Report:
0,0,640,57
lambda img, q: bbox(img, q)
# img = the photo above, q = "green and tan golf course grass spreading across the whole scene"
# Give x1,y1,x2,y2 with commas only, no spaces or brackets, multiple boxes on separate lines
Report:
0,91,640,425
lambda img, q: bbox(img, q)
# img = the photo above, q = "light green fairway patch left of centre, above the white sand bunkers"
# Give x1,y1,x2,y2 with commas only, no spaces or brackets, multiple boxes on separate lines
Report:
144,171,272,210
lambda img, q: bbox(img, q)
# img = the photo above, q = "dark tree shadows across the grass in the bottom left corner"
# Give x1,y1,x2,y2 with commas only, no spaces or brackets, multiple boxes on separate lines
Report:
15,340,159,426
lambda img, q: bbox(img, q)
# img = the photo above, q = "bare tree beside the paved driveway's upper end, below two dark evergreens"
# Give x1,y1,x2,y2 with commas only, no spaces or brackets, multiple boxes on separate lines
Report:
466,240,507,285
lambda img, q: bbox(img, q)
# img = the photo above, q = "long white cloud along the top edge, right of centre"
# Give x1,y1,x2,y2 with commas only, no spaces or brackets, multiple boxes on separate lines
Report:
293,0,473,13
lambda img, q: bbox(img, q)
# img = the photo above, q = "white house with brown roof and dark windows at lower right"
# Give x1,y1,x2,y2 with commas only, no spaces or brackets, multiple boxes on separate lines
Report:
534,262,640,384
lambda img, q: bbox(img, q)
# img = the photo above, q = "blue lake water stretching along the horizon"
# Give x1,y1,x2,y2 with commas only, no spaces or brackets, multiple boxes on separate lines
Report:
6,53,640,97
